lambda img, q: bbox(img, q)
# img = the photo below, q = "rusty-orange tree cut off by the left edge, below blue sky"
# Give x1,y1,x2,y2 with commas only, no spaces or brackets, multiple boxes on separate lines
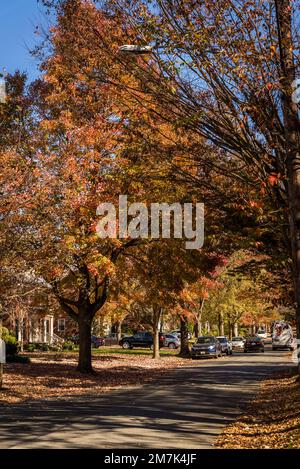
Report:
0,71,35,322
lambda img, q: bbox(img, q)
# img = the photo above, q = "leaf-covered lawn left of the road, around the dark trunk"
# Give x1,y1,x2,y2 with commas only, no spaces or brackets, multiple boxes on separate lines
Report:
0,353,188,404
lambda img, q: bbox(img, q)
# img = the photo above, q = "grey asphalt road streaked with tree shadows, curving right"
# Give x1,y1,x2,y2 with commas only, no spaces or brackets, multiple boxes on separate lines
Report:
0,348,293,449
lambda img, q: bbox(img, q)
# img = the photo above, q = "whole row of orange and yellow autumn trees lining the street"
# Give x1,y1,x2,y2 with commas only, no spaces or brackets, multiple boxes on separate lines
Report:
0,0,299,372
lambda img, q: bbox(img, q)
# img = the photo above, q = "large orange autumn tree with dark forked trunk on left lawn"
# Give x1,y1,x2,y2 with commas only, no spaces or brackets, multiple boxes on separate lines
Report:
20,2,149,372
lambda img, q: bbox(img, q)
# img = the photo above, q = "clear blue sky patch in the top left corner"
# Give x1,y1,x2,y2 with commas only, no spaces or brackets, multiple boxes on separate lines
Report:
0,0,47,79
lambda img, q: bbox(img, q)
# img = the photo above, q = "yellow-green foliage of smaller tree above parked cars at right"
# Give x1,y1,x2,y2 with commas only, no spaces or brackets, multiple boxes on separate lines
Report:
203,250,288,337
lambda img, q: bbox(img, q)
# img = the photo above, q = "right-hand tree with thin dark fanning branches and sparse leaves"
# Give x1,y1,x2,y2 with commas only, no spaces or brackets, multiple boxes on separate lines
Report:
101,0,300,354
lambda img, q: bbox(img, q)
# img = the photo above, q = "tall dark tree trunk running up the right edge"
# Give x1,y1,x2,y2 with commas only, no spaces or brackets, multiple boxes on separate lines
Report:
275,0,300,372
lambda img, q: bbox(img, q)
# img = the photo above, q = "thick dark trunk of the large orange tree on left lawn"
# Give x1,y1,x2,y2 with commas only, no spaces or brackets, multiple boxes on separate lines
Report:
77,308,93,373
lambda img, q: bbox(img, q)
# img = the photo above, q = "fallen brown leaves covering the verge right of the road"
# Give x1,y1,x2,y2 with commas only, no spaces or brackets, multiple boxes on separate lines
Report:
216,372,300,449
